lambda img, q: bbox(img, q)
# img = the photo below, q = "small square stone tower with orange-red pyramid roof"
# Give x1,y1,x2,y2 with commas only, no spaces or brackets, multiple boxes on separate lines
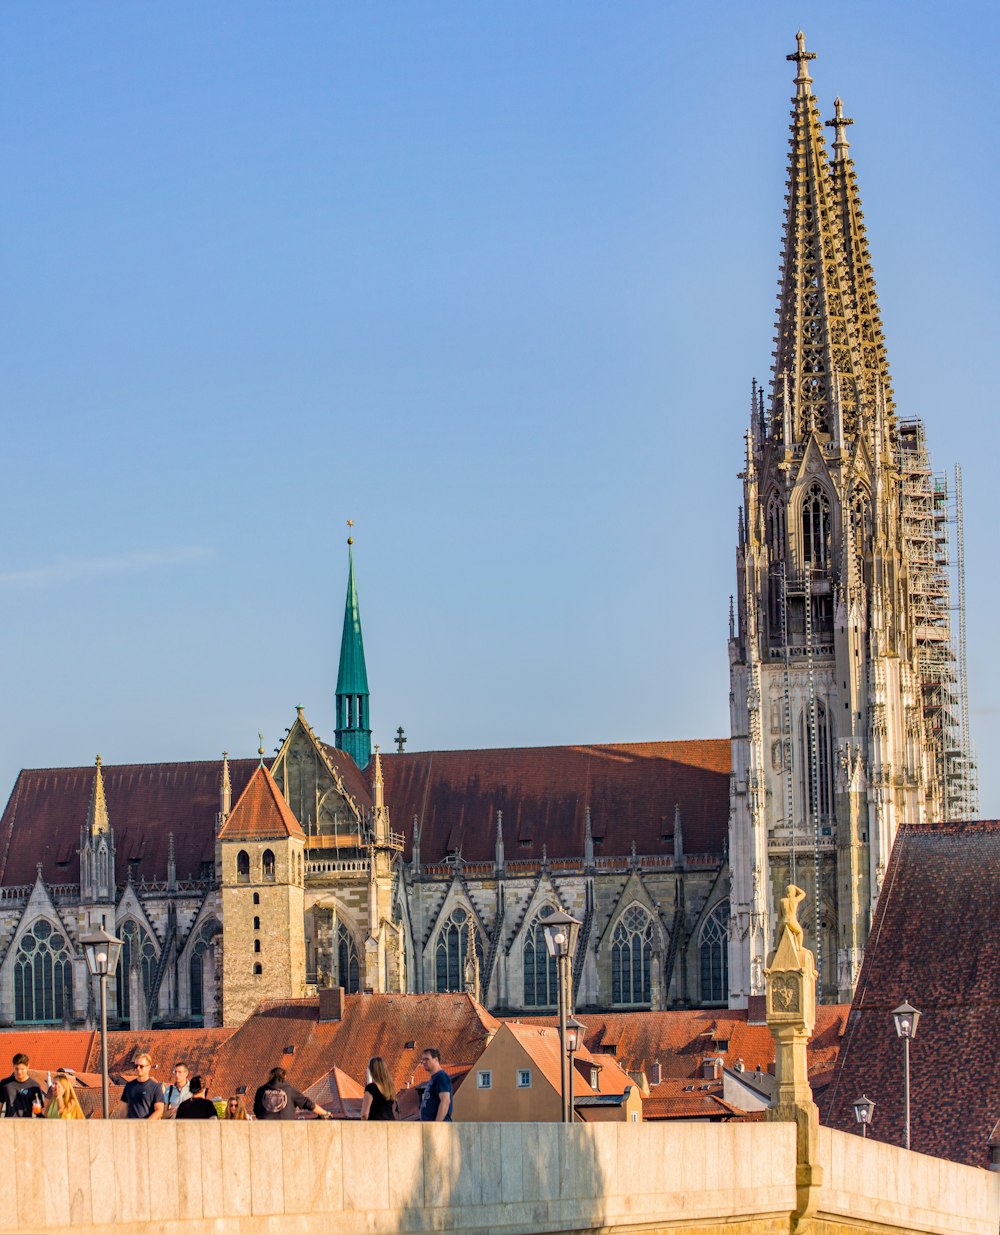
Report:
217,751,306,1025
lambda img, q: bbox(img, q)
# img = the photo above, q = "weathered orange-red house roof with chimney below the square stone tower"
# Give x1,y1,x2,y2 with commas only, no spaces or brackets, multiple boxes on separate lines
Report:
207,994,500,1094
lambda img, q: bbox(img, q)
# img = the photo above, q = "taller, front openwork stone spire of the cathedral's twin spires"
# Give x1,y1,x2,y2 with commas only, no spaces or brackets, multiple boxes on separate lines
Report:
770,31,858,447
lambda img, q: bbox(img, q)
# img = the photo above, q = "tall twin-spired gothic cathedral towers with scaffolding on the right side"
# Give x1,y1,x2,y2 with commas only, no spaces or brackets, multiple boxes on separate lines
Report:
730,32,972,1008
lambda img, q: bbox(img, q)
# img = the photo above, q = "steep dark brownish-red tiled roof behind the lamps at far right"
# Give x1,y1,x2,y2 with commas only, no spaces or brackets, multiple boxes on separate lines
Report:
821,820,1000,1167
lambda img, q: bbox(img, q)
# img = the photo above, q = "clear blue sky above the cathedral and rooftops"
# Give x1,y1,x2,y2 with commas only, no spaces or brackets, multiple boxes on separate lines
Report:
0,0,1000,815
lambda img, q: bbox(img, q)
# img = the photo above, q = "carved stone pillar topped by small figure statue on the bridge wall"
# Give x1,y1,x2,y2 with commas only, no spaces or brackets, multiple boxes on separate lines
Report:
764,884,822,1235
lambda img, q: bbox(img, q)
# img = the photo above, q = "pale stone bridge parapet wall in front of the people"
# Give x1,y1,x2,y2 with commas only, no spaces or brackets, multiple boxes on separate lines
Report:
0,1120,1000,1235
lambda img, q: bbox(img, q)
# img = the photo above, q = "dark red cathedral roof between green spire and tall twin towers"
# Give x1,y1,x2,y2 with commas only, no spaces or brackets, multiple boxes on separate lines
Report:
372,739,730,862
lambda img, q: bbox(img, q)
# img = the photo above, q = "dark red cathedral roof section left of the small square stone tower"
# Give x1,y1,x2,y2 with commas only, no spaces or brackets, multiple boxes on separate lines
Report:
0,760,257,887
